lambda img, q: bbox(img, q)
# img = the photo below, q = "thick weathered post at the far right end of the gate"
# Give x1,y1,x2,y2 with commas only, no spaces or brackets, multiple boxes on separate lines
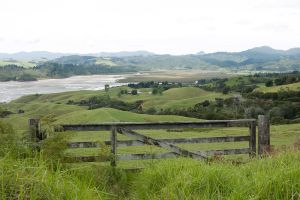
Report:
258,115,270,157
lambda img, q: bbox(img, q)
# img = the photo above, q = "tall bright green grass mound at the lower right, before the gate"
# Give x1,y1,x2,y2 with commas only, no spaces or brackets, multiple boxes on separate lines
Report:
131,152,300,200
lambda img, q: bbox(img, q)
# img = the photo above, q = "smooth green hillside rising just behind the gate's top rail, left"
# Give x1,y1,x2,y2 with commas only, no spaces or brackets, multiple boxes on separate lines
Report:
4,102,196,130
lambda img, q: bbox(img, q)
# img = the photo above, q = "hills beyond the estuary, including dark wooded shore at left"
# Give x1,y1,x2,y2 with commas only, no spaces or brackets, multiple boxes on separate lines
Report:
0,46,300,81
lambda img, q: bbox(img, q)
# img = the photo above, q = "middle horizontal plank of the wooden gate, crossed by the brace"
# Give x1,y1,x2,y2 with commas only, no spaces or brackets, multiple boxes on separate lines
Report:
68,136,250,148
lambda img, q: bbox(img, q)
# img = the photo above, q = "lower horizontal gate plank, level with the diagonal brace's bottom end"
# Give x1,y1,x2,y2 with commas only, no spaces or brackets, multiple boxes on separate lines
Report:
65,148,251,162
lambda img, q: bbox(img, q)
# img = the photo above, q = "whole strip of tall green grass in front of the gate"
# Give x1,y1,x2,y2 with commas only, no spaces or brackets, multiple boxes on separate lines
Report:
0,151,300,200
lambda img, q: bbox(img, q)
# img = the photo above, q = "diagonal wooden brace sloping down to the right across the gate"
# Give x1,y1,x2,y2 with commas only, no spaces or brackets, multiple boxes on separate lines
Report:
117,128,207,159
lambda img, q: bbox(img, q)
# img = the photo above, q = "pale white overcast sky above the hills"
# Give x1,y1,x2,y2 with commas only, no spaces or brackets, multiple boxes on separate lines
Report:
0,0,300,55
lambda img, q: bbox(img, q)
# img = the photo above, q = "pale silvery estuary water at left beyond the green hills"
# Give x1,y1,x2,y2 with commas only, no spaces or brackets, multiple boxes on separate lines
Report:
0,75,125,102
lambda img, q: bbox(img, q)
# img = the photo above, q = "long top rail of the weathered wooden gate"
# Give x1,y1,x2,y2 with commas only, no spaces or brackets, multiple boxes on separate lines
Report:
60,119,255,131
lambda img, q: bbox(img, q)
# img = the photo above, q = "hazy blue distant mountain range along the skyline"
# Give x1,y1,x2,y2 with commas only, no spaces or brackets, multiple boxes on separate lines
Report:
0,46,300,71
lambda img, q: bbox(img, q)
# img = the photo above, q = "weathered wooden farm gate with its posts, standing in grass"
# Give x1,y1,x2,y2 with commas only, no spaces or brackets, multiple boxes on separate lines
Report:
29,115,270,166
